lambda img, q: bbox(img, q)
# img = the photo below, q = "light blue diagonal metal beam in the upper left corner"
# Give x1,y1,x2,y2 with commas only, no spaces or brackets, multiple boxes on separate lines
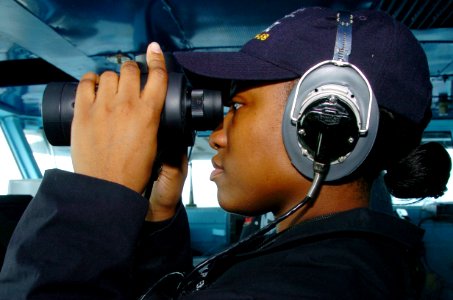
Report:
0,0,98,79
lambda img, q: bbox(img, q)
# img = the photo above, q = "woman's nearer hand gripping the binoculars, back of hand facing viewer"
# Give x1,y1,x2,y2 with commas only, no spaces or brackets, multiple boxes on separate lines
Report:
71,43,167,193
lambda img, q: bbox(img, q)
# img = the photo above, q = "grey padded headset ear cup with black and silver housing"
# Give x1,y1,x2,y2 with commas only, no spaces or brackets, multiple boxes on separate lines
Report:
282,61,379,181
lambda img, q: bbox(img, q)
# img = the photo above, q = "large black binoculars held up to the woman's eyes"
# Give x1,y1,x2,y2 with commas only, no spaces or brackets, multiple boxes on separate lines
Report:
42,72,223,147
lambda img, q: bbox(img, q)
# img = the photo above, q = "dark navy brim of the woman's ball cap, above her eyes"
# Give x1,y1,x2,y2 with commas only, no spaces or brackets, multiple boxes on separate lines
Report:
174,52,300,80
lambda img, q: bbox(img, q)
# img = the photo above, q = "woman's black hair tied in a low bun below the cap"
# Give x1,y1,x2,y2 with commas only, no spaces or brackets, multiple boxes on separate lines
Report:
358,108,451,198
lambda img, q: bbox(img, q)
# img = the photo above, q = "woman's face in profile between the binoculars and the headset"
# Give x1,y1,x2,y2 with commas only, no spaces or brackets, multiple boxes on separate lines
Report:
210,82,307,215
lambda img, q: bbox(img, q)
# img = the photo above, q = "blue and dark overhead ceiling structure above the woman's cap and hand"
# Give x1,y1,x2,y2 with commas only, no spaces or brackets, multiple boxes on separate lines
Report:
0,0,453,117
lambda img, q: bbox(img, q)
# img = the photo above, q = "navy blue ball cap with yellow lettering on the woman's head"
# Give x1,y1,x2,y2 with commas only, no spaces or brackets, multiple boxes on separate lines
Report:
174,7,432,126
